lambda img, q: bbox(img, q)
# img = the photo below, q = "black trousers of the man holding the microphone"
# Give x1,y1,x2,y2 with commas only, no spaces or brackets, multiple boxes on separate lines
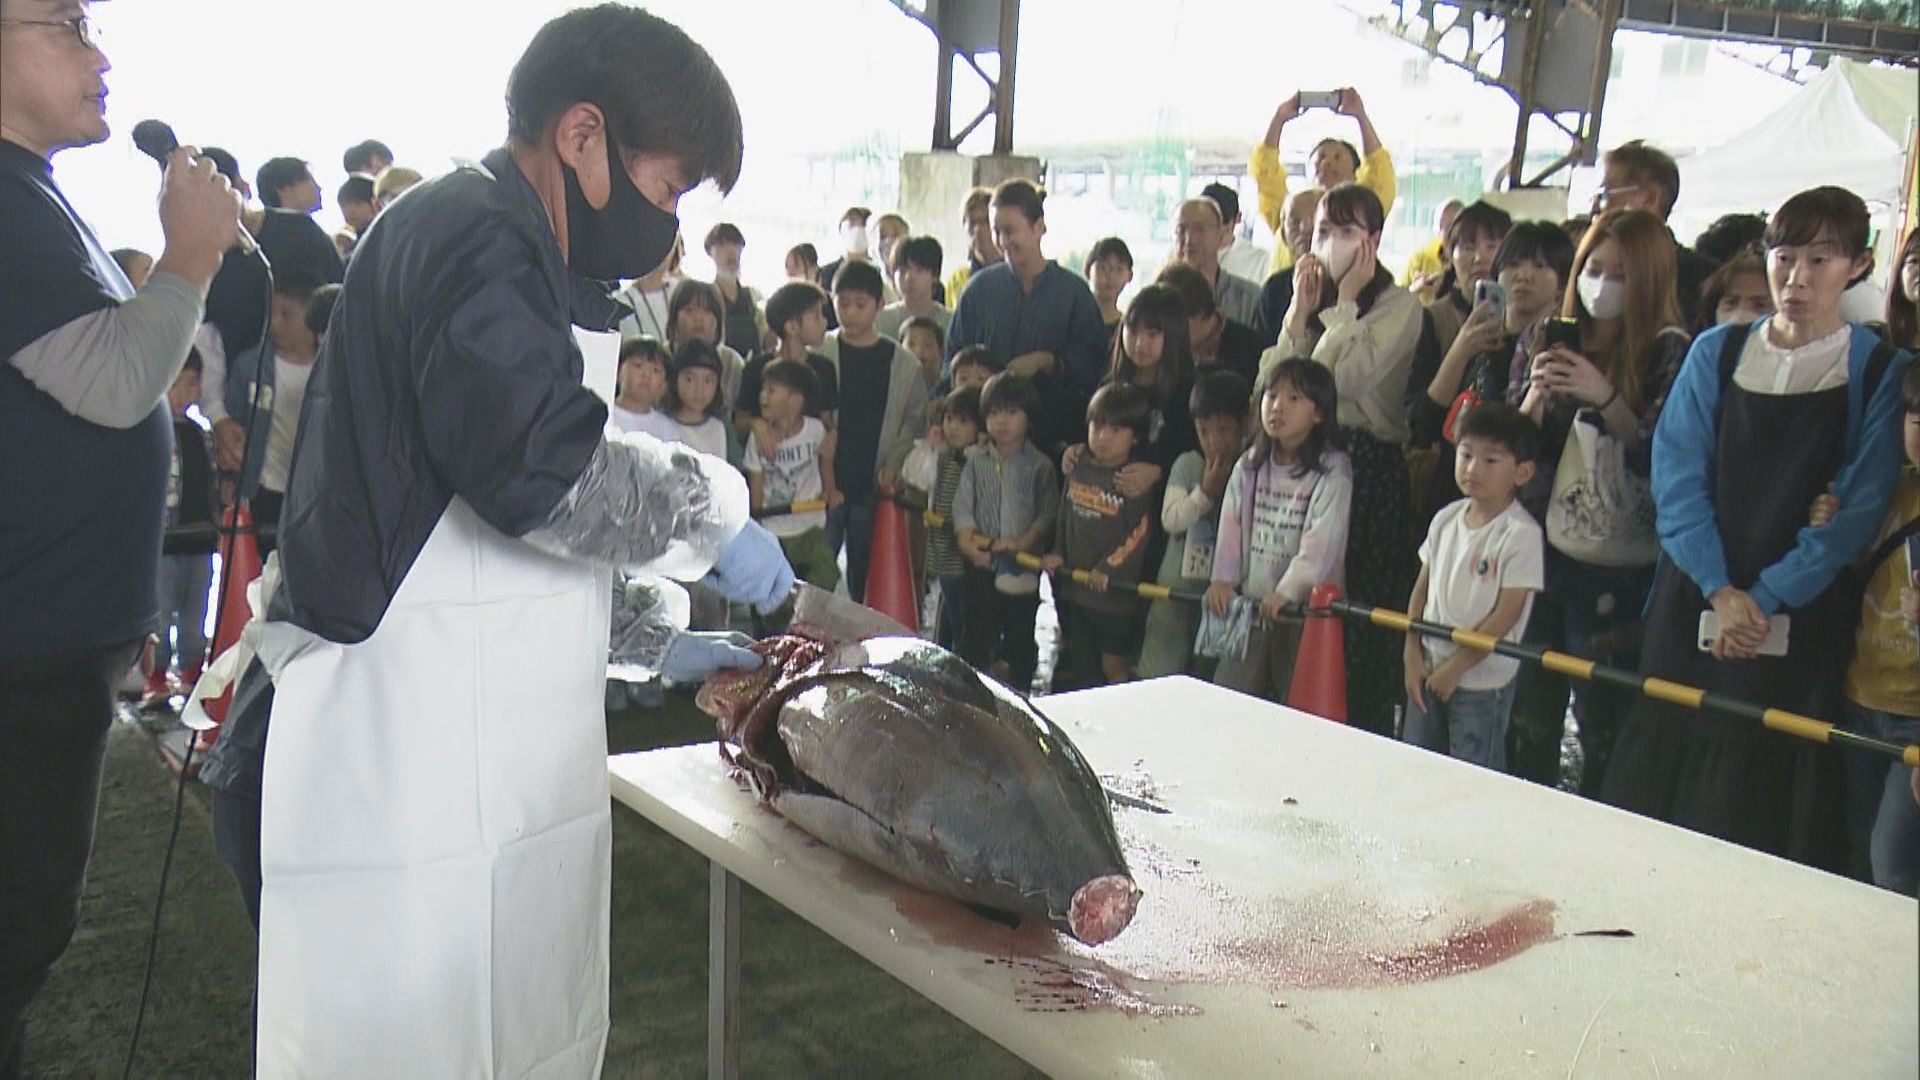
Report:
0,642,140,1080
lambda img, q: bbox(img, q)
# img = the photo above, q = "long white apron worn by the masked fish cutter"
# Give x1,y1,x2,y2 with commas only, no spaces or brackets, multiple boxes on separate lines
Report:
257,498,612,1078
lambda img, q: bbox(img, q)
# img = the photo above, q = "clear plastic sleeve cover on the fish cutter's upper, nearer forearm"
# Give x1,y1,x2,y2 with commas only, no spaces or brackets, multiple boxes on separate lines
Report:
524,432,749,580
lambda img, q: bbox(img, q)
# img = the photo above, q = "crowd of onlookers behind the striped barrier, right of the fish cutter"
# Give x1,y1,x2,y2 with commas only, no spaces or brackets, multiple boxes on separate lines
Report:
576,102,1920,892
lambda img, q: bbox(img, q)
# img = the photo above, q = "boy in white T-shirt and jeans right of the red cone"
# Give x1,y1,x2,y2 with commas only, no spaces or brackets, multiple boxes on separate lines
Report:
1402,402,1546,771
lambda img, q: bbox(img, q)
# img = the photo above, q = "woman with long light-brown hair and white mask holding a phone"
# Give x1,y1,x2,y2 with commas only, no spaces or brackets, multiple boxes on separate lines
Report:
1507,209,1688,796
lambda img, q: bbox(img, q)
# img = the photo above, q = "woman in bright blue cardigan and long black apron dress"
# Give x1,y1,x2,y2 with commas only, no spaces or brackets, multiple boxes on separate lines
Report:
1603,186,1910,869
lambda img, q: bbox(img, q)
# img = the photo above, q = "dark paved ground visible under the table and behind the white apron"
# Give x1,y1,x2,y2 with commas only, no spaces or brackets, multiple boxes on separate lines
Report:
27,696,1033,1076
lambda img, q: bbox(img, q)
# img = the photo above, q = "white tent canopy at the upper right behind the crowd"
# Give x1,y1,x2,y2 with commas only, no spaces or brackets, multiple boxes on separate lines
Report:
1674,58,1920,236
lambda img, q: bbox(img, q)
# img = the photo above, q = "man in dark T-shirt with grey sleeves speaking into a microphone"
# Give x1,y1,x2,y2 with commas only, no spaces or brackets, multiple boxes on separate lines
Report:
0,0,240,1078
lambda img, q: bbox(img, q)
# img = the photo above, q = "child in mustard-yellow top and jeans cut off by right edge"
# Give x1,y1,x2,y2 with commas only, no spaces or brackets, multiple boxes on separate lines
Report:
1814,361,1920,896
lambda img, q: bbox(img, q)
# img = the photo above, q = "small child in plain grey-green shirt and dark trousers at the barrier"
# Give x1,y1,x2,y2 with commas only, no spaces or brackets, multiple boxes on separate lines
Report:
952,373,1060,694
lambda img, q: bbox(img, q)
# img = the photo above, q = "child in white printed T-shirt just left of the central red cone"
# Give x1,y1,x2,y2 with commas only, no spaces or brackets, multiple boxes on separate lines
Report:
743,359,843,592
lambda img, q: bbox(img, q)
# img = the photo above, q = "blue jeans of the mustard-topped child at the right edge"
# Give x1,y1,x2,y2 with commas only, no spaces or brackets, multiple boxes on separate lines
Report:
1847,701,1920,896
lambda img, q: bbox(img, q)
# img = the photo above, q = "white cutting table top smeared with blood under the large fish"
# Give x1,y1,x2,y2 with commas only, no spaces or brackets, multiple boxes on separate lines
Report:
609,678,1920,1078
